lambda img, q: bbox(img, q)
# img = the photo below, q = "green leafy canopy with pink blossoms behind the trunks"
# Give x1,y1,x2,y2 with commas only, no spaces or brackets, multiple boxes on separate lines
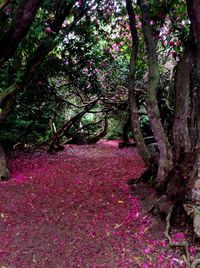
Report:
0,0,192,148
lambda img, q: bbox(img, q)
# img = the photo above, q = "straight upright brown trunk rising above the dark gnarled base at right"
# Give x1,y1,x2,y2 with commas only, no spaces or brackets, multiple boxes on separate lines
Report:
173,40,194,160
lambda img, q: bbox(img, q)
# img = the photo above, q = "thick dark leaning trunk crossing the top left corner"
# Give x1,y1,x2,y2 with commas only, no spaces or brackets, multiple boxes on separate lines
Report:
0,0,42,64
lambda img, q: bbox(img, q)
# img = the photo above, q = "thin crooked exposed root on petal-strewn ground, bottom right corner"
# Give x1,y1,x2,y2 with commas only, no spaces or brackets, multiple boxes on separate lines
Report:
165,206,200,268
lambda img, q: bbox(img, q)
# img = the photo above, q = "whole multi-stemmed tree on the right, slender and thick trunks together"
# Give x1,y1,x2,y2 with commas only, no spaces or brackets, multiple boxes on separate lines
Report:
126,0,200,239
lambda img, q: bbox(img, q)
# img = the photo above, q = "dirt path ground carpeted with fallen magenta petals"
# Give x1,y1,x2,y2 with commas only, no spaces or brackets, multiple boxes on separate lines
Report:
0,142,195,268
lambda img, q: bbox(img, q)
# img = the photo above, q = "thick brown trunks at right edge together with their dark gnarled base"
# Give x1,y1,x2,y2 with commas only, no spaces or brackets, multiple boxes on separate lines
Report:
162,0,200,237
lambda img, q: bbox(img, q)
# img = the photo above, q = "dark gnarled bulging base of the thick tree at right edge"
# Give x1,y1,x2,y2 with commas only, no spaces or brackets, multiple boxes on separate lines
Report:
167,147,200,237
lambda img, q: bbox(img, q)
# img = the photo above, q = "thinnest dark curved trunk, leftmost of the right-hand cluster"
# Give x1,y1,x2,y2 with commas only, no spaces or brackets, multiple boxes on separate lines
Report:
126,0,151,166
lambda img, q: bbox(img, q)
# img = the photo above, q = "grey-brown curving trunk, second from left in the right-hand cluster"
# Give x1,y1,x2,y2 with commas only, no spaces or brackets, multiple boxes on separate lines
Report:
138,0,173,188
